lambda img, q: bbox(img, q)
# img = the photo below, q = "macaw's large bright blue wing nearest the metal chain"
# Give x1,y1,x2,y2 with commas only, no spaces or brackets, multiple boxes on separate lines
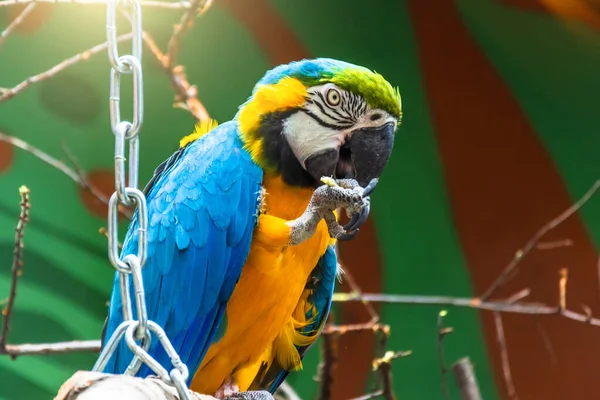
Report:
104,122,263,377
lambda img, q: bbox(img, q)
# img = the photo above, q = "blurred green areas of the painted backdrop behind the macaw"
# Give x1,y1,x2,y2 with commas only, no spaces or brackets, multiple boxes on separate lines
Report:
0,0,600,400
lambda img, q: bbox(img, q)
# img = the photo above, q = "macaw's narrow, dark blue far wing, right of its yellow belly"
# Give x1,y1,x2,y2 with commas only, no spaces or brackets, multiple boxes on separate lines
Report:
253,246,337,393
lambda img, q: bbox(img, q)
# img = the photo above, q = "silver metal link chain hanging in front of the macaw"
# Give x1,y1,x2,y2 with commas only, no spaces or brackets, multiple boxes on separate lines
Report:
93,0,191,400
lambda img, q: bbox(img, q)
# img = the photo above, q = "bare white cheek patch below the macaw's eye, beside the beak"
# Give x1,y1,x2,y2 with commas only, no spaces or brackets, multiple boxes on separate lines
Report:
283,111,346,168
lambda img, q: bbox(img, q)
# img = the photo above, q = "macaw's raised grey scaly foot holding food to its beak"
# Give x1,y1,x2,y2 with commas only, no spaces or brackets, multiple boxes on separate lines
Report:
287,179,376,245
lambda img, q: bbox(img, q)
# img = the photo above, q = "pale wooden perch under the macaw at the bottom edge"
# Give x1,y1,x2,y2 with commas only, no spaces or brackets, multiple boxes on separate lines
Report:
54,371,274,400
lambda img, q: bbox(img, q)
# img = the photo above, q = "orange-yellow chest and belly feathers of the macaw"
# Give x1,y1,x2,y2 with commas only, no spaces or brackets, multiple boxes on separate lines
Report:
191,175,330,394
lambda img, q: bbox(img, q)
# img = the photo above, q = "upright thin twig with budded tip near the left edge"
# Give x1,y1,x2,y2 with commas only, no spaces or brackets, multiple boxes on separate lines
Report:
0,186,31,353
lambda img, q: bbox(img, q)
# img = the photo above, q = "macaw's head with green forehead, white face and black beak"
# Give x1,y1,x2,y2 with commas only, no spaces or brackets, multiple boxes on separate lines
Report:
236,58,402,187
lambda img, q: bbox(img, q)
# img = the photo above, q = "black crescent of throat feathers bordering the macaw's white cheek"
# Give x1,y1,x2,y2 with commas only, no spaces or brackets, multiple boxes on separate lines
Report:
258,109,319,187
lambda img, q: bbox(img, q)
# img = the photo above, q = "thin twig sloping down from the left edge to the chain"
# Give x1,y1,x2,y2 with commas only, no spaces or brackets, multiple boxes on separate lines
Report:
0,131,132,219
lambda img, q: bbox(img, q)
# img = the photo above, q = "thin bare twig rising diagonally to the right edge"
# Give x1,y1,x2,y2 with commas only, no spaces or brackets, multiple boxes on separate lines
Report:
480,180,600,301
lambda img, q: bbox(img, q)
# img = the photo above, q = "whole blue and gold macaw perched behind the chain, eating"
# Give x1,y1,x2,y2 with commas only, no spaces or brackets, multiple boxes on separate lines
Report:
103,58,402,397
